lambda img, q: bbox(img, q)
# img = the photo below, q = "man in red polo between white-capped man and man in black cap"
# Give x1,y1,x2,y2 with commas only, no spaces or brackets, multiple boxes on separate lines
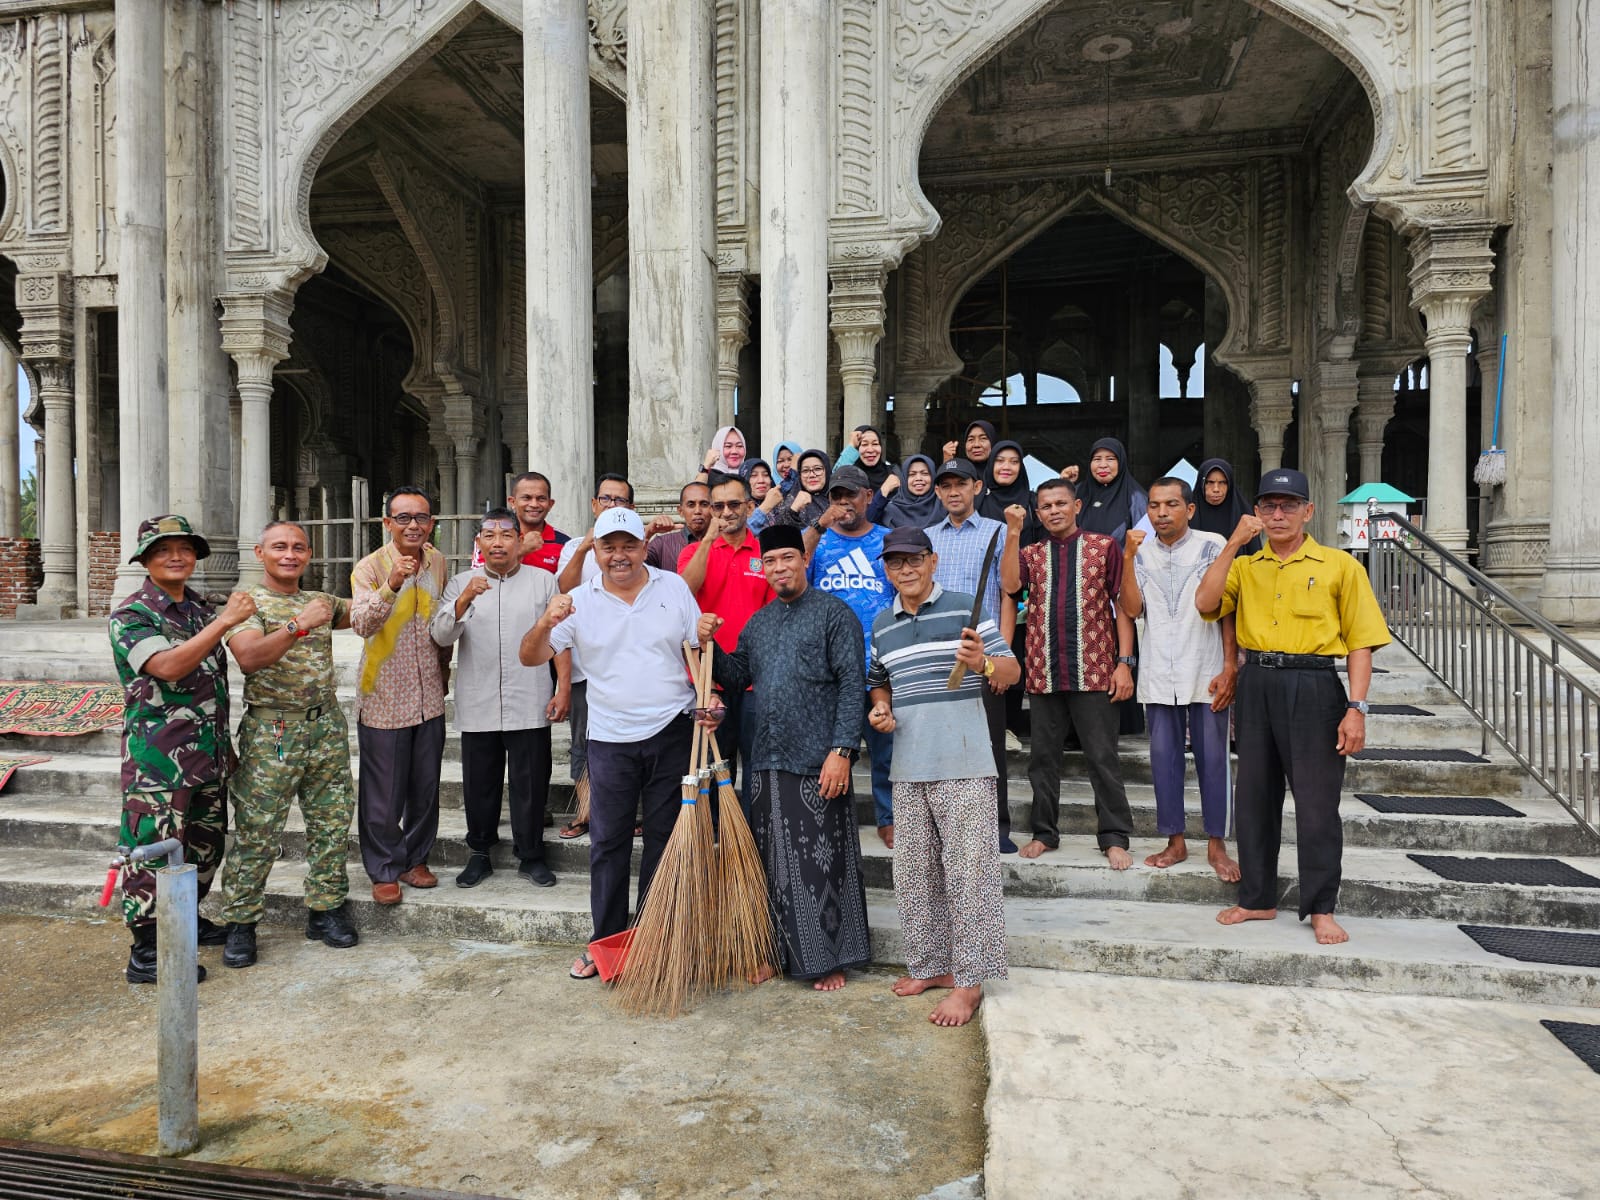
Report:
678,475,773,800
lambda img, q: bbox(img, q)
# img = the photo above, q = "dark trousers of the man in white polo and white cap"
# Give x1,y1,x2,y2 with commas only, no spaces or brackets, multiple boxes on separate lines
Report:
589,717,694,939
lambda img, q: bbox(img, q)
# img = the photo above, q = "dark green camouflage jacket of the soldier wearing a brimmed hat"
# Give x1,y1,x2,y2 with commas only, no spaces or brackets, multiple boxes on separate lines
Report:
110,579,234,792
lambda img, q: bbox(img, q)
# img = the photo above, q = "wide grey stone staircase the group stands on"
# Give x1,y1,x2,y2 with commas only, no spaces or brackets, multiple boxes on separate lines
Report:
0,621,1600,1005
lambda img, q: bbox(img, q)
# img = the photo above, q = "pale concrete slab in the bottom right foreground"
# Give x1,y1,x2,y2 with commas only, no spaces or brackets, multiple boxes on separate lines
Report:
984,972,1600,1200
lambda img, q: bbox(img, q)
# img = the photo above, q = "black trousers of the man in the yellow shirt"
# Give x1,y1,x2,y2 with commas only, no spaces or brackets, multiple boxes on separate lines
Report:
1234,662,1346,918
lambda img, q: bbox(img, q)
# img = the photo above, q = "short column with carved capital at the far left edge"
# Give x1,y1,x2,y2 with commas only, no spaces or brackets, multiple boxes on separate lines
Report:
10,274,76,616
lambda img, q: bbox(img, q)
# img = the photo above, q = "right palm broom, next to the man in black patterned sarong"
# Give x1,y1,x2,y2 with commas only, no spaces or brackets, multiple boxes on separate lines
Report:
701,645,778,986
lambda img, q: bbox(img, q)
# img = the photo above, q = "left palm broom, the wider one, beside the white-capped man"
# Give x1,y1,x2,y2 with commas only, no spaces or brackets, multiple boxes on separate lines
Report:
616,649,715,1016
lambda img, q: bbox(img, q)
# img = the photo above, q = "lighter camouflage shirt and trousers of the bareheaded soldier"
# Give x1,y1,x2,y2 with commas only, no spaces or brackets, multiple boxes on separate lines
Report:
222,586,355,925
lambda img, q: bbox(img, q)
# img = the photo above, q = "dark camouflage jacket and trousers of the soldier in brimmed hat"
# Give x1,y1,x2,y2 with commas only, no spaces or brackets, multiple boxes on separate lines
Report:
110,579,234,925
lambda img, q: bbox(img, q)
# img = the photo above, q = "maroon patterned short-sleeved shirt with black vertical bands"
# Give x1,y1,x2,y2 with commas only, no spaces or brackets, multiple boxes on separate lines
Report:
1021,530,1122,696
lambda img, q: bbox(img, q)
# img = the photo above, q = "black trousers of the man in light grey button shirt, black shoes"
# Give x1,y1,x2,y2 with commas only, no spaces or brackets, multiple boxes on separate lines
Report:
461,726,550,862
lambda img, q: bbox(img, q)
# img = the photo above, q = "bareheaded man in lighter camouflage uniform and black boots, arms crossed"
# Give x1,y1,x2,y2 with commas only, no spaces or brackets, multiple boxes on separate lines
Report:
222,522,358,966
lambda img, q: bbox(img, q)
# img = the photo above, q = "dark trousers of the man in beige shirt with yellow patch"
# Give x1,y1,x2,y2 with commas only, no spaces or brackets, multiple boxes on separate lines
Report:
355,714,445,883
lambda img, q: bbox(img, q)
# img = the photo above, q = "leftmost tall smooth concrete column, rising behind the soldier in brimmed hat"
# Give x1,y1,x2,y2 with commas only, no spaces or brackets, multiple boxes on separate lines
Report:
112,0,168,603
